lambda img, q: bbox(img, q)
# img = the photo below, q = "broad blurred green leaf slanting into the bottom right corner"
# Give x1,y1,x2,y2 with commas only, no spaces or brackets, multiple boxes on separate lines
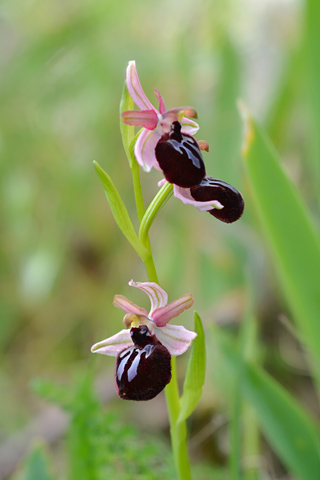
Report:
213,327,320,480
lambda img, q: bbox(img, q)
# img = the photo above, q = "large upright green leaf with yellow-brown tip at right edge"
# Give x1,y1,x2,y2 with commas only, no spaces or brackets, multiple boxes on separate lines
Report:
243,105,320,372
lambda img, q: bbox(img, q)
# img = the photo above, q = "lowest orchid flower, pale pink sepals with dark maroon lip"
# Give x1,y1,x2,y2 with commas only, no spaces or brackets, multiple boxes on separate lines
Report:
91,280,197,400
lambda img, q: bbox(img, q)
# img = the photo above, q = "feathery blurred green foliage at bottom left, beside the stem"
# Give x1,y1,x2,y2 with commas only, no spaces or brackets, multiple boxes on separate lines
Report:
18,376,178,480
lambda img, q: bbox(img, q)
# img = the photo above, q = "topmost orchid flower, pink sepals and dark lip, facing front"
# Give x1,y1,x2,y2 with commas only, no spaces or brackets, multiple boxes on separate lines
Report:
122,61,205,188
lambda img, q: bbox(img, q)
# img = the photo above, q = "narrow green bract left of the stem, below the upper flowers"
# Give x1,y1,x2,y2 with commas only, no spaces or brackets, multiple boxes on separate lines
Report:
93,162,150,259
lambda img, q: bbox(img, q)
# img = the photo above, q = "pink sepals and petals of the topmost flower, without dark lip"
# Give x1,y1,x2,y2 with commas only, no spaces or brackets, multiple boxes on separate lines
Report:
122,60,199,172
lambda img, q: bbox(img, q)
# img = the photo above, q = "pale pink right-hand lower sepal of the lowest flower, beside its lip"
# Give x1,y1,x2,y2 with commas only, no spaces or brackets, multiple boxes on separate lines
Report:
154,325,197,357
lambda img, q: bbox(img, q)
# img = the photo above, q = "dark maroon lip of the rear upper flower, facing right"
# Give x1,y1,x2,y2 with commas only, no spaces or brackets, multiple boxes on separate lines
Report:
190,177,244,223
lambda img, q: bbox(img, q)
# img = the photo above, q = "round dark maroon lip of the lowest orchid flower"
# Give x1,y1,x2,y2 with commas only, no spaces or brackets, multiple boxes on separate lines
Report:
116,325,171,400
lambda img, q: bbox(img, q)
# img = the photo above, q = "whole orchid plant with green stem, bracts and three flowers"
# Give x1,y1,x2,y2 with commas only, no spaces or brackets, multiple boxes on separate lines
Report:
91,62,212,480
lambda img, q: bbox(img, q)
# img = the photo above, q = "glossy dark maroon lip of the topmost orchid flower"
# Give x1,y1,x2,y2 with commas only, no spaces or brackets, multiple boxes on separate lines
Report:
156,122,206,188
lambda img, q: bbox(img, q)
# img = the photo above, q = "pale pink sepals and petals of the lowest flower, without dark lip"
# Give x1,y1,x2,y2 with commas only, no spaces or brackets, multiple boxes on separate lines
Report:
91,280,197,357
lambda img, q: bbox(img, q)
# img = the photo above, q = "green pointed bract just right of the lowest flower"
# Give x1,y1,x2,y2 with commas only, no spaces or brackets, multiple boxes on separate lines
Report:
177,312,206,423
